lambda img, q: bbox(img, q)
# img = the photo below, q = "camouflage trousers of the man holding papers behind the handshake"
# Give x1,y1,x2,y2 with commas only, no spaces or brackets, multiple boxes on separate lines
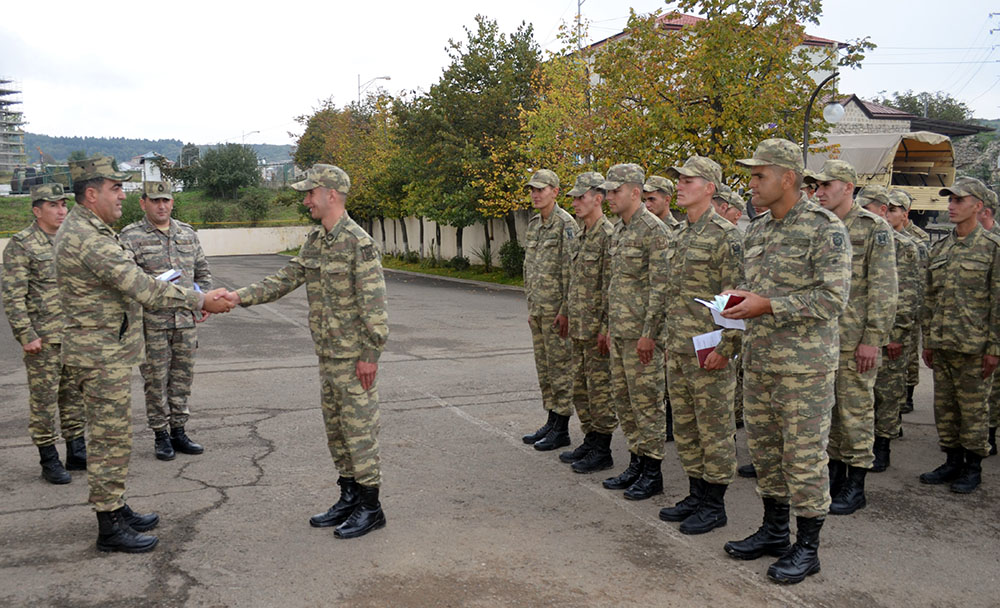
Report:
139,327,198,431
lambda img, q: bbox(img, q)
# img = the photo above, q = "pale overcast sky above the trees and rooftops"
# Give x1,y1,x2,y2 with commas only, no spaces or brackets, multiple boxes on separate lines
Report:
0,0,1000,144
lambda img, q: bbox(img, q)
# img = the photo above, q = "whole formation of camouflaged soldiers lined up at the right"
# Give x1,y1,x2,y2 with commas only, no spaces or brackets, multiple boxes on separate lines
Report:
523,139,1000,583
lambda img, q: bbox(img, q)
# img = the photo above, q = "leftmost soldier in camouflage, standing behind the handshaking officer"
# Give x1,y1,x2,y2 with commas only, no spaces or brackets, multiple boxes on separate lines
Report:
3,183,87,484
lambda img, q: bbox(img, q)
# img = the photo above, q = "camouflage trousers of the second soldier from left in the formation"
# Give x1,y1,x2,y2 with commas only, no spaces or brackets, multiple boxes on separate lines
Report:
573,338,618,435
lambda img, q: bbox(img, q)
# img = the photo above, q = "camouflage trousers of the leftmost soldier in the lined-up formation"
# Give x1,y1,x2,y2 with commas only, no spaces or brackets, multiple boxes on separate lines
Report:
528,316,573,416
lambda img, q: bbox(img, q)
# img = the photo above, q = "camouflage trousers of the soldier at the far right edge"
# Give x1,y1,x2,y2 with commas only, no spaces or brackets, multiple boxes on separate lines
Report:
934,350,993,457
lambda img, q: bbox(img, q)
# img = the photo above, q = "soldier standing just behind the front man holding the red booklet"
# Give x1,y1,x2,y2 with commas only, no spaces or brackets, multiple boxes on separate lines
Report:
805,165,898,515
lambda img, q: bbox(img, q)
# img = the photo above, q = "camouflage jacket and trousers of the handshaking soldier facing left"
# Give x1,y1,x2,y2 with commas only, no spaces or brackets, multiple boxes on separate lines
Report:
236,213,389,486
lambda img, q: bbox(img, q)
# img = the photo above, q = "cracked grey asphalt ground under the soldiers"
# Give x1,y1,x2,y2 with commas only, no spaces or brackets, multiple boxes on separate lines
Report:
0,256,1000,608
